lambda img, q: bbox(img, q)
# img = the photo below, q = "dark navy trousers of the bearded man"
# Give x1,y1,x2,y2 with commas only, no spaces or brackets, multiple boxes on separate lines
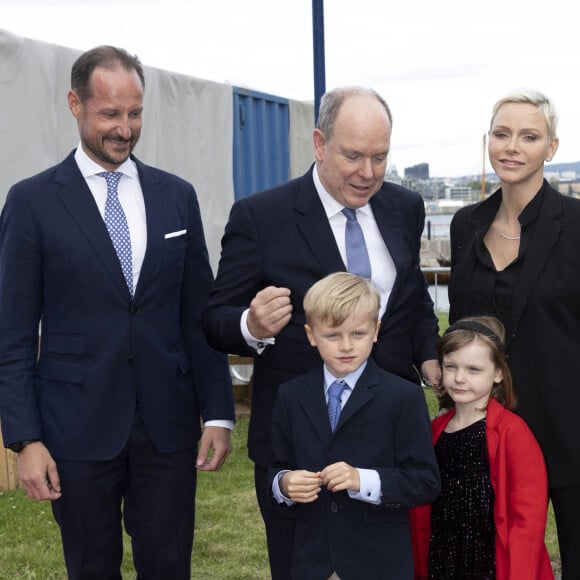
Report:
52,419,197,580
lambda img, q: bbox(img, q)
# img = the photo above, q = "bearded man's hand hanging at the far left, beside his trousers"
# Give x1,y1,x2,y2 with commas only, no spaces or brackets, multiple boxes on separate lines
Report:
16,441,62,501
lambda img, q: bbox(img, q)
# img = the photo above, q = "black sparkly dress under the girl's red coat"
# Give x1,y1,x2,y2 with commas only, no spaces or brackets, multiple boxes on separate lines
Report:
429,419,495,580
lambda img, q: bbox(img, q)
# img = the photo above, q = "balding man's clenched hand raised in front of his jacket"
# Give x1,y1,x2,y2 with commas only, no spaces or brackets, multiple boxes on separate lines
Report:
247,286,292,339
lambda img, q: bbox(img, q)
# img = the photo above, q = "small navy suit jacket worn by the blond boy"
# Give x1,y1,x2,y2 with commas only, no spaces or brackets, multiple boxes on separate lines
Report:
268,360,439,580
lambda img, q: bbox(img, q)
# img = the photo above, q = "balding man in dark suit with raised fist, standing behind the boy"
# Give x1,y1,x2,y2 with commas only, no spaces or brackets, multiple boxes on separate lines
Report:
204,87,439,580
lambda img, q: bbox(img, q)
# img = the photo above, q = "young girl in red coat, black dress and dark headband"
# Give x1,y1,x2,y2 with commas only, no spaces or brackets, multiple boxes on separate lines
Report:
411,317,554,580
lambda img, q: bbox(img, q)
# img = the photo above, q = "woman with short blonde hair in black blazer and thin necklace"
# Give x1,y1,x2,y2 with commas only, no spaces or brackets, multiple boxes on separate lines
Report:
449,90,580,580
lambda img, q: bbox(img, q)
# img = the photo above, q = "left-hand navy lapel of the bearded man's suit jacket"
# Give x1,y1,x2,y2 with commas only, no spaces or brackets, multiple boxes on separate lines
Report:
55,152,131,301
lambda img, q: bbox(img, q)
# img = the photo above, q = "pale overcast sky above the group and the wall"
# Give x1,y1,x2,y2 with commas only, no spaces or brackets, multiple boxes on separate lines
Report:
0,0,580,176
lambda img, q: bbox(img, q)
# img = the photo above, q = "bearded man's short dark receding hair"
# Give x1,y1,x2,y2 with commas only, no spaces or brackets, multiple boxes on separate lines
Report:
70,46,145,101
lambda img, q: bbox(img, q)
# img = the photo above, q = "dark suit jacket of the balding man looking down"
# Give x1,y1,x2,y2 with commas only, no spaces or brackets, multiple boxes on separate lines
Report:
204,169,437,467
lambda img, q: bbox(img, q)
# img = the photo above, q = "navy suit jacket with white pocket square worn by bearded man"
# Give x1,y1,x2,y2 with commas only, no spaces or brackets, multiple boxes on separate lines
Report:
0,153,233,460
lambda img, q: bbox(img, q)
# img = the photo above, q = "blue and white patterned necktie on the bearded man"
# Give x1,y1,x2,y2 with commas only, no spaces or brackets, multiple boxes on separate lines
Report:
98,171,133,296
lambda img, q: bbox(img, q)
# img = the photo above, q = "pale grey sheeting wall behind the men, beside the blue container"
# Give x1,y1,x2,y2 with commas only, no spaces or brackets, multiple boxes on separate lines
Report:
0,29,314,270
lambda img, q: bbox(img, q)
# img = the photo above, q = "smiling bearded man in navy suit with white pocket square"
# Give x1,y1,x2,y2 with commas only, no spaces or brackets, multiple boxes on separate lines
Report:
0,46,234,580
